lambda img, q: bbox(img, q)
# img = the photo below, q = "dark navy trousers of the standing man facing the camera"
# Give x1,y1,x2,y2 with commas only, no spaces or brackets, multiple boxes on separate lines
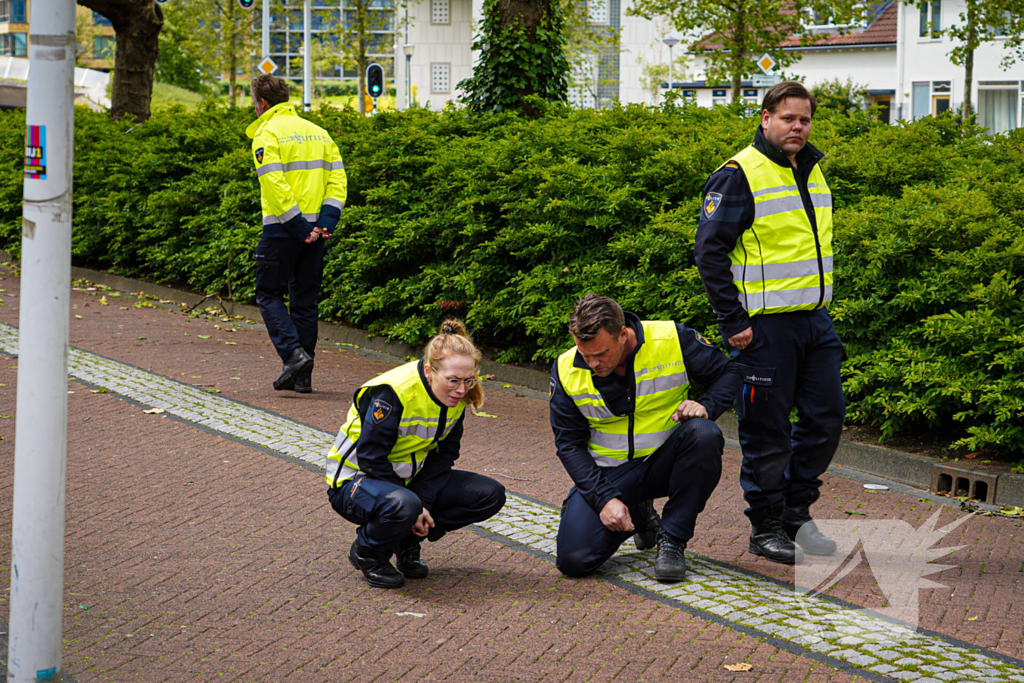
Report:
729,308,846,519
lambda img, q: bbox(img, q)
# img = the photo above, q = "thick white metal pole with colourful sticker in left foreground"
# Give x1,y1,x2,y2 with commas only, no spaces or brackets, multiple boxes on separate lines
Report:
7,0,75,683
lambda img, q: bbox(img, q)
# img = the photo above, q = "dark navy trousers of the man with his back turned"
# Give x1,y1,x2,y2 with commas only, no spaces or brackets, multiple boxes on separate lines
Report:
256,238,324,360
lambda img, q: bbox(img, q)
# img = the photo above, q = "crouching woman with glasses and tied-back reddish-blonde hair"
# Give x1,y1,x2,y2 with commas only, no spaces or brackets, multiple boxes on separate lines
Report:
327,321,505,588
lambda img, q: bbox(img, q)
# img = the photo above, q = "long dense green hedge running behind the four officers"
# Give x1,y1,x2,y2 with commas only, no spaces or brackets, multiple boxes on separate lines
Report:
0,105,1024,453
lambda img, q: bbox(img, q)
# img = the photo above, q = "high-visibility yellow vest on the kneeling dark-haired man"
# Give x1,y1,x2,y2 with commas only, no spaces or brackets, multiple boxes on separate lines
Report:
558,321,690,467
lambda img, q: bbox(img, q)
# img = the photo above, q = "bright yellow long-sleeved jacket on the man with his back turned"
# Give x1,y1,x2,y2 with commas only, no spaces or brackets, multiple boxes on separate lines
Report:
246,102,348,240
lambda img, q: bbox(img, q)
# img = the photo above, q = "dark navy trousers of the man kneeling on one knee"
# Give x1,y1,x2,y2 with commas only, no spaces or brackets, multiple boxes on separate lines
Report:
555,418,725,577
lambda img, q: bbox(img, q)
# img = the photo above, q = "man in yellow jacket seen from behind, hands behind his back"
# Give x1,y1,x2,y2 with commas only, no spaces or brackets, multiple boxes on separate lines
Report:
246,75,348,393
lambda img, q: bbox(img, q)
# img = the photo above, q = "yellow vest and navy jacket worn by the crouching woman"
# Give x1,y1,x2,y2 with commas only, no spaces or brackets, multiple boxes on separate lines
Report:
326,360,466,509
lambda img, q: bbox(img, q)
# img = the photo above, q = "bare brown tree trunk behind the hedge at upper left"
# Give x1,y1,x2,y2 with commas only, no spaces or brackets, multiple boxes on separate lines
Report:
79,0,164,122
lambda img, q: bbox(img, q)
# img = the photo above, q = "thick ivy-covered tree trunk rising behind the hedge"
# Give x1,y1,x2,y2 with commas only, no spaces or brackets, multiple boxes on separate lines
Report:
459,0,569,116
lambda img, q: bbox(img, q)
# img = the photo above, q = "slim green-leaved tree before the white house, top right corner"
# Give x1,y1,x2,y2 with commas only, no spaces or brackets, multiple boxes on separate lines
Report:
918,0,1024,122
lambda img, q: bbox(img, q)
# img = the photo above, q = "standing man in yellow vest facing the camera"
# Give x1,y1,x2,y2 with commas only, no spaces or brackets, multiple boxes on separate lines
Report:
695,81,846,564
